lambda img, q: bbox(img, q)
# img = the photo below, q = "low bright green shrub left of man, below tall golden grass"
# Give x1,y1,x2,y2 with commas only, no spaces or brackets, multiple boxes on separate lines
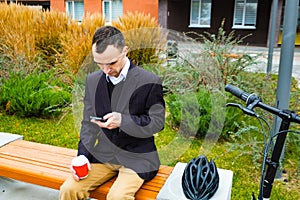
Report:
0,70,72,117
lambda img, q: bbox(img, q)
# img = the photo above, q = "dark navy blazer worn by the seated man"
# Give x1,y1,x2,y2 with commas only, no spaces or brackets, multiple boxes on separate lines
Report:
78,63,165,180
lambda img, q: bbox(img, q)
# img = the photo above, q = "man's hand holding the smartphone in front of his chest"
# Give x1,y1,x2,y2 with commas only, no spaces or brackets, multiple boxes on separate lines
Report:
91,112,122,130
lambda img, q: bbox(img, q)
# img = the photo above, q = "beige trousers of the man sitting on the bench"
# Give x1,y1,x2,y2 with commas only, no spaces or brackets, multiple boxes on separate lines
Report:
59,164,144,200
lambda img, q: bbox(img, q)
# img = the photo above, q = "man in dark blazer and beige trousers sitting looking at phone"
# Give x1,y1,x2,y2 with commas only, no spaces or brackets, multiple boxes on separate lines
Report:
60,26,165,200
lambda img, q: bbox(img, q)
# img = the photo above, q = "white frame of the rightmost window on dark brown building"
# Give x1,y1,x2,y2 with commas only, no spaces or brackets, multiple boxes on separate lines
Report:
232,0,258,29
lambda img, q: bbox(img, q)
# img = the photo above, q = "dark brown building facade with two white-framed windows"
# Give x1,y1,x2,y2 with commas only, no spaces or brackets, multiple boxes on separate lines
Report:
159,0,300,46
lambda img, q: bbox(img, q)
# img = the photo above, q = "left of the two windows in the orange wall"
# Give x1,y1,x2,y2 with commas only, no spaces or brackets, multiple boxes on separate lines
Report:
66,1,84,22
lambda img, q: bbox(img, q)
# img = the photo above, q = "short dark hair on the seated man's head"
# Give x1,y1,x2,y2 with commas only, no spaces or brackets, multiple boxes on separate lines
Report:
92,26,125,53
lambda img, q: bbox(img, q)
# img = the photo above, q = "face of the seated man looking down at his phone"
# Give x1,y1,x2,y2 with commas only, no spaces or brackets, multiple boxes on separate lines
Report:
92,44,127,77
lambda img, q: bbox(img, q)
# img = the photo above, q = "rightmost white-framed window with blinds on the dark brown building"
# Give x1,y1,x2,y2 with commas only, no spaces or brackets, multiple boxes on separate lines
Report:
233,0,258,29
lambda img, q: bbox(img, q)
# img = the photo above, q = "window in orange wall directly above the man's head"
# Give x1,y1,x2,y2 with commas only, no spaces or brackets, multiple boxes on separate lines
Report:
103,0,123,23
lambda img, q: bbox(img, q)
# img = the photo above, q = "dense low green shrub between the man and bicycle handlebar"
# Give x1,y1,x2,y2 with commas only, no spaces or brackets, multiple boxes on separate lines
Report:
166,86,225,138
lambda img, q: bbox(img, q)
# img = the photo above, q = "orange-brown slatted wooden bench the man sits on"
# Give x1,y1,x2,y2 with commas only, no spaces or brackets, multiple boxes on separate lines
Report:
0,140,173,200
